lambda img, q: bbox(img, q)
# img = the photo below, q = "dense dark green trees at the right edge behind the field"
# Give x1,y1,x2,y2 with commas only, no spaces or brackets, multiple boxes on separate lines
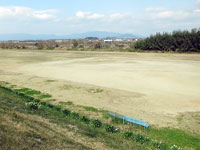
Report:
134,28,200,52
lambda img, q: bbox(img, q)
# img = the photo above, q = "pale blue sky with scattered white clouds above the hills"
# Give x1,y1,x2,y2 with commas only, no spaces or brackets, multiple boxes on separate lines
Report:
0,0,200,36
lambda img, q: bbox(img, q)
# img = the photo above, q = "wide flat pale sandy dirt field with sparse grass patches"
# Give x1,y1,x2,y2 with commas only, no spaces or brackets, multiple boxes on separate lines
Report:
0,50,200,133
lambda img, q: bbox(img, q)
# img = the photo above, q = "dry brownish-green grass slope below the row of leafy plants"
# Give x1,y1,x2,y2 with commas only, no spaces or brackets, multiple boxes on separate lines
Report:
0,85,148,150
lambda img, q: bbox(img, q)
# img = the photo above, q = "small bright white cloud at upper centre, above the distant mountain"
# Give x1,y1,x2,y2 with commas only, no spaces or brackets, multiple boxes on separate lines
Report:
76,11,105,19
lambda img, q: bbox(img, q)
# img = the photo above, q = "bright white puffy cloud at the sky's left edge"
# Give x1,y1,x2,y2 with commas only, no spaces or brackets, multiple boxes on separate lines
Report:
0,6,58,20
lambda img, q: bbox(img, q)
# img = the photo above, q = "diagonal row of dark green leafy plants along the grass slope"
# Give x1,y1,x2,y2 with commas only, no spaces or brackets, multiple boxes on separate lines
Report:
0,86,188,150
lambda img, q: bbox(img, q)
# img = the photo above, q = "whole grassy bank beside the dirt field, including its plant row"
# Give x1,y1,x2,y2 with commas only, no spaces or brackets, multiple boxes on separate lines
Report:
0,82,200,150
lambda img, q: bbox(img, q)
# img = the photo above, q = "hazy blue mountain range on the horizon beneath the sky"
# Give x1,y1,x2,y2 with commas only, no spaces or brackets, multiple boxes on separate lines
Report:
0,31,142,41
